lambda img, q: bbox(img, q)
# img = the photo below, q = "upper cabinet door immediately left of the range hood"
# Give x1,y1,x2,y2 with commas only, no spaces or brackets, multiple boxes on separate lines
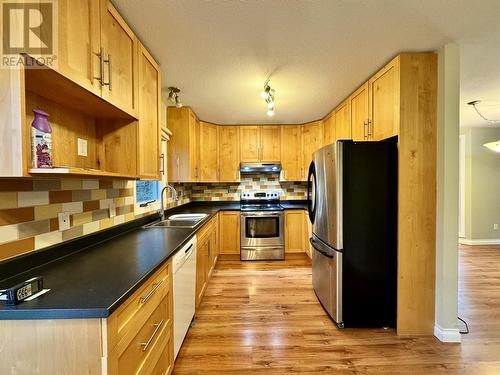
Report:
219,126,240,182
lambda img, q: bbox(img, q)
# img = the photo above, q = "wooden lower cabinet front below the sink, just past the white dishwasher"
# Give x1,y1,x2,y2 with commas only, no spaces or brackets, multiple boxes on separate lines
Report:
196,215,219,308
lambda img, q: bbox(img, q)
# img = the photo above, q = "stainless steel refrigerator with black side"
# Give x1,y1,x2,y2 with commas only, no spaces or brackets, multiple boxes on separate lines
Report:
308,138,398,328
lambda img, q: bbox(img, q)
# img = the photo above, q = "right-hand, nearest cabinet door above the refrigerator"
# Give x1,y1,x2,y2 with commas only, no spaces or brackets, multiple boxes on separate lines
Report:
369,58,399,141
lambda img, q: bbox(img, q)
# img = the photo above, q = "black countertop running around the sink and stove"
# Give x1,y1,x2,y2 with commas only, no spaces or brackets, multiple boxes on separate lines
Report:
0,201,306,320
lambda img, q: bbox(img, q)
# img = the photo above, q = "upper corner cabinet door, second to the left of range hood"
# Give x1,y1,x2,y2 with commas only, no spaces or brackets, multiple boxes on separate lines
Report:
200,122,218,182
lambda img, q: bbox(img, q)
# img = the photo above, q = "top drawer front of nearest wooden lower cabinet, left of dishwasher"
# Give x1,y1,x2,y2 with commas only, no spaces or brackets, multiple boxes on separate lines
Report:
108,260,172,351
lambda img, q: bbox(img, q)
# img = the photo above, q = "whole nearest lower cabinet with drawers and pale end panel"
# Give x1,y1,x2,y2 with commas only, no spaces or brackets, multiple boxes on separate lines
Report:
0,260,174,375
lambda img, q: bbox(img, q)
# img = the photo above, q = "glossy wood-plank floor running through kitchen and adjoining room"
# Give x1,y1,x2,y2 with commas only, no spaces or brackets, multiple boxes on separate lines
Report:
174,247,500,374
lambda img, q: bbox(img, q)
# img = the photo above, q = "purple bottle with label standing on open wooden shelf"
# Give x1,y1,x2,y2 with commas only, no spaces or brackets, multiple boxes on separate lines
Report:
31,109,52,168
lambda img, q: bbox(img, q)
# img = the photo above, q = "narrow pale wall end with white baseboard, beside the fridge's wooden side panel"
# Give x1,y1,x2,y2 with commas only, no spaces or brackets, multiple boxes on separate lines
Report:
434,44,461,342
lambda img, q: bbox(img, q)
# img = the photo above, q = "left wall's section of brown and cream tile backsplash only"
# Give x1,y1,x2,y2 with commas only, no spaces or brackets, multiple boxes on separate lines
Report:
0,178,179,261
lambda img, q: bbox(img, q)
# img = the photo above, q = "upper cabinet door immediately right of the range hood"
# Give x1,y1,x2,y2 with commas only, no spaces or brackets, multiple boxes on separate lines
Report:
281,125,302,181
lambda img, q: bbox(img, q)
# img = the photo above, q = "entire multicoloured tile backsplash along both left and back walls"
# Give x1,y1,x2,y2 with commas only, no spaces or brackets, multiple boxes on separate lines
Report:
0,174,307,261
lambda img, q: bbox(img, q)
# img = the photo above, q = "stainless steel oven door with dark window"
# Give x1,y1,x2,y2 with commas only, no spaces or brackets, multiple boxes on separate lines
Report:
241,212,284,248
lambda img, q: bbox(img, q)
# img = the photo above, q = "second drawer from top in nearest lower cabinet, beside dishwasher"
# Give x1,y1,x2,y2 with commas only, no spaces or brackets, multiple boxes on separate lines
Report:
109,296,172,375
